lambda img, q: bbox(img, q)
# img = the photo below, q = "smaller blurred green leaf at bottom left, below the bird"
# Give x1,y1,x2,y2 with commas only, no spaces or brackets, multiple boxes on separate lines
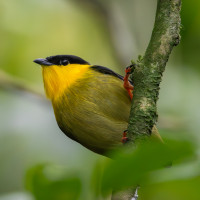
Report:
26,165,82,200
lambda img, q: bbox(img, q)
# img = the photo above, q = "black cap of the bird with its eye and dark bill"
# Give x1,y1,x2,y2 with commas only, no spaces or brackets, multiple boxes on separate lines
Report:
33,55,89,66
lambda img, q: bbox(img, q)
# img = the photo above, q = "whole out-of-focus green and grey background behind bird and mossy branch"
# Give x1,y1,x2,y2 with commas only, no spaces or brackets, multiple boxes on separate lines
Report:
0,0,200,200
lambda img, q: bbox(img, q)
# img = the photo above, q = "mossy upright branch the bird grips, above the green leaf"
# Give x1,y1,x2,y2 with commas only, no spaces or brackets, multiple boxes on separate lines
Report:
128,0,181,143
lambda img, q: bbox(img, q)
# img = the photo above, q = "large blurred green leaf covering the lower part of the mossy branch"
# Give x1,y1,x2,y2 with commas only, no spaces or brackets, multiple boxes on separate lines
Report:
102,140,194,194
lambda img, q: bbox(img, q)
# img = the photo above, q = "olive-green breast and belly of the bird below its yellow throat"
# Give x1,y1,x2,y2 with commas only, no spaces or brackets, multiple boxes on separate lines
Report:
53,74,131,154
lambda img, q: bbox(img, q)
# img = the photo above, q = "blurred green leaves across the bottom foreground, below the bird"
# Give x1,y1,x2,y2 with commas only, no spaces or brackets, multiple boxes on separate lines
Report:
26,135,200,200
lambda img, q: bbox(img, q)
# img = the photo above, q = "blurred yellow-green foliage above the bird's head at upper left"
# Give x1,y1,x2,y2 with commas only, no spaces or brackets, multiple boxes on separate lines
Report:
0,0,119,81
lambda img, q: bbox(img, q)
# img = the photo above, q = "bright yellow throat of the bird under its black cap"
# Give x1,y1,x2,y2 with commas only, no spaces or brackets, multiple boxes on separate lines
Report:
42,64,90,101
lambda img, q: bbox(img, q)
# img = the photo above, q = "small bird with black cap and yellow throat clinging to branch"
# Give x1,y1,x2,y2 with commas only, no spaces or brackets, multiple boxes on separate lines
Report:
34,55,160,156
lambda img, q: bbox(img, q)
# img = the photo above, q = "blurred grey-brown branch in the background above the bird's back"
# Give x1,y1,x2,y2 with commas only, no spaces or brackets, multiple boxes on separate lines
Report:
72,0,136,66
